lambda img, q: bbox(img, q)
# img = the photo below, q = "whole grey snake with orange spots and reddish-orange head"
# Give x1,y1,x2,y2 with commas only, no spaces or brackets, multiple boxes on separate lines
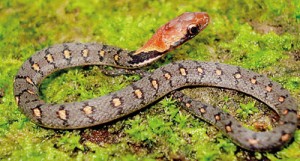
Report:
14,12,297,151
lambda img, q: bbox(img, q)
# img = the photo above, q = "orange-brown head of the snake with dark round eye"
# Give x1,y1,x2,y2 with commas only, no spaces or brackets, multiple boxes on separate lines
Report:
133,12,209,55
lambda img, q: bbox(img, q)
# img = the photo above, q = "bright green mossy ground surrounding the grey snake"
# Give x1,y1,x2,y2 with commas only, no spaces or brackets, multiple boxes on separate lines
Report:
0,0,300,160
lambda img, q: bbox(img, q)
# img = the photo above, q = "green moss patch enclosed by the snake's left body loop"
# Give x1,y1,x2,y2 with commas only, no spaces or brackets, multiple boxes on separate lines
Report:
41,67,130,103
